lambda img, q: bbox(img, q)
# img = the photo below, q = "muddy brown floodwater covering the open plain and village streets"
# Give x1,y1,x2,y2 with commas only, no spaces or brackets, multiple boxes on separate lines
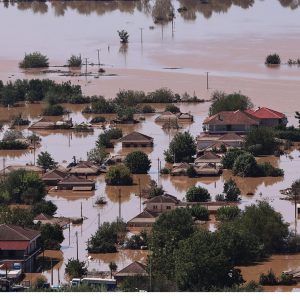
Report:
0,0,300,290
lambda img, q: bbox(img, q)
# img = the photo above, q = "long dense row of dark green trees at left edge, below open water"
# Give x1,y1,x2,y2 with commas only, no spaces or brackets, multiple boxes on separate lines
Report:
0,79,83,106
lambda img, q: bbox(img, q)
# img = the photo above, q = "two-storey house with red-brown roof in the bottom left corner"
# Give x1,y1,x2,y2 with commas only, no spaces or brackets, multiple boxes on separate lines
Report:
0,224,41,273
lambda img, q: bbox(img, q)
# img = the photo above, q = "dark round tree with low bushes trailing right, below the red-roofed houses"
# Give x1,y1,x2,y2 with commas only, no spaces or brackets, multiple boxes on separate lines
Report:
222,149,284,177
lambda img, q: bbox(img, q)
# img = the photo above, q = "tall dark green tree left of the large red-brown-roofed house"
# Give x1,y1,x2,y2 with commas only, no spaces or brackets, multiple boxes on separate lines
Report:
164,132,196,163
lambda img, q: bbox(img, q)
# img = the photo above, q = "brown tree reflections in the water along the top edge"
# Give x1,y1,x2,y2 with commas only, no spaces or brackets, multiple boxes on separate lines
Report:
3,0,300,19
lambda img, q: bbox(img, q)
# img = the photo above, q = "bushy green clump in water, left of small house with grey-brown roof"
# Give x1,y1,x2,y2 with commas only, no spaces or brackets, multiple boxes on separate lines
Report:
87,219,126,253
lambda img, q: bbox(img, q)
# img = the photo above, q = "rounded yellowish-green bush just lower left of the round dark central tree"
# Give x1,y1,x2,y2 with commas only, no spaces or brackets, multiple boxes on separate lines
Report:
105,165,133,185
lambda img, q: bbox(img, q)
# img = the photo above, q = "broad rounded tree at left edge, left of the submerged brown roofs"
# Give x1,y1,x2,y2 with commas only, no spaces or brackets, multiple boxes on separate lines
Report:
0,169,46,204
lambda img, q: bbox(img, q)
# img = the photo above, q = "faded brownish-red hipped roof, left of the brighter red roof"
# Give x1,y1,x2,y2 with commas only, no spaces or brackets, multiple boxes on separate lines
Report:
203,110,259,125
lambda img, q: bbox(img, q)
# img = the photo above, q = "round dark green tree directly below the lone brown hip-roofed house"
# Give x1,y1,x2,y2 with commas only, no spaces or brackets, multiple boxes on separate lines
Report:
125,151,151,174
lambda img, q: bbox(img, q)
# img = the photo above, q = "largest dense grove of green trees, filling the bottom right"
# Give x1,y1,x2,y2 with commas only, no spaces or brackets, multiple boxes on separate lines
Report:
148,202,300,291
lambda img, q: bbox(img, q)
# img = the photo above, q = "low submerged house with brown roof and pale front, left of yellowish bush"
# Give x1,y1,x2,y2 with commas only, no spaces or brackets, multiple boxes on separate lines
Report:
57,174,96,191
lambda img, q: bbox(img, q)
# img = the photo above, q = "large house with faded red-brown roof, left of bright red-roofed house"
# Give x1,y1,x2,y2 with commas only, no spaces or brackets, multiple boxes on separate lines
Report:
203,110,260,134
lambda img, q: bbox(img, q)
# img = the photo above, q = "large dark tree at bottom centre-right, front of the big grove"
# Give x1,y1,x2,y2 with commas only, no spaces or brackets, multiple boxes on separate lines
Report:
175,230,244,292
